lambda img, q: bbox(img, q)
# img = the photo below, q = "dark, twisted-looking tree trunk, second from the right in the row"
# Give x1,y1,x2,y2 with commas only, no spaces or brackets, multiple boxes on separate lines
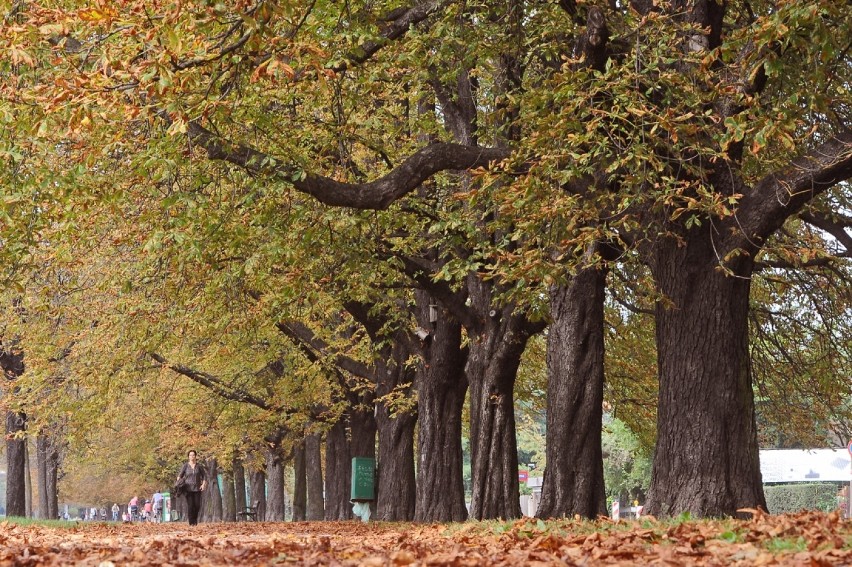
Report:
537,268,606,518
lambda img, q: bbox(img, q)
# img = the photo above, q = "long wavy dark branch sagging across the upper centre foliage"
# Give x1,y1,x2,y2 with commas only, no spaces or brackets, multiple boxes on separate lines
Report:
187,122,510,210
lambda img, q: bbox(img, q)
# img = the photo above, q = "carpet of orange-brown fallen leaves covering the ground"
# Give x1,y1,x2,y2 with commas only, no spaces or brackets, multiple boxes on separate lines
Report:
0,512,852,567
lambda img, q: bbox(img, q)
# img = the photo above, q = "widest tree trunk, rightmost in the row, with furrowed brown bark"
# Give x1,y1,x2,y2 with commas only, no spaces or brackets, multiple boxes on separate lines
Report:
646,233,766,517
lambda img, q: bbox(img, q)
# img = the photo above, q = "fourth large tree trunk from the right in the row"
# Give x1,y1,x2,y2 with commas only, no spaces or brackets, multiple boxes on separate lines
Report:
414,308,467,522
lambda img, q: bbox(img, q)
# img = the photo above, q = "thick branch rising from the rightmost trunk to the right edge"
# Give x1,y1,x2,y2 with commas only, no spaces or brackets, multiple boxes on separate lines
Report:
737,132,852,246
